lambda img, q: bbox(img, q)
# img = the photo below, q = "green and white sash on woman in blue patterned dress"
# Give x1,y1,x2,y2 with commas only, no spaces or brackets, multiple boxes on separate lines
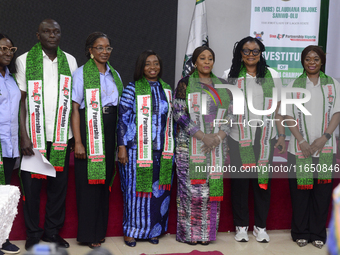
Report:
135,76,174,197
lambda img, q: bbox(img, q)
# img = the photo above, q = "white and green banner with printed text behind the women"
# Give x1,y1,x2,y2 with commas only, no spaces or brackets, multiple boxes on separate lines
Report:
250,0,320,85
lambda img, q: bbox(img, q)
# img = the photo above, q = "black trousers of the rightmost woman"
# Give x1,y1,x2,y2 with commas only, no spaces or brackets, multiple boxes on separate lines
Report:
288,153,336,243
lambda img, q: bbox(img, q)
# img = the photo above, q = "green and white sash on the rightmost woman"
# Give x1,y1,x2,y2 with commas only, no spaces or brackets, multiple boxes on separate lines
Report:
292,71,336,189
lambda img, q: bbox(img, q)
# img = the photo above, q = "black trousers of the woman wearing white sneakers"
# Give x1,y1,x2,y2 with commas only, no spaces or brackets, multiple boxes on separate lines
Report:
228,128,276,228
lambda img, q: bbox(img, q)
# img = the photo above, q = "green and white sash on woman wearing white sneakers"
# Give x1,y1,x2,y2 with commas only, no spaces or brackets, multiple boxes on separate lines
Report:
237,67,275,190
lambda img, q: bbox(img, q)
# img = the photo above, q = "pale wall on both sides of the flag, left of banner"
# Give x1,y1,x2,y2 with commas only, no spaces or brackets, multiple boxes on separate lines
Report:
175,0,251,82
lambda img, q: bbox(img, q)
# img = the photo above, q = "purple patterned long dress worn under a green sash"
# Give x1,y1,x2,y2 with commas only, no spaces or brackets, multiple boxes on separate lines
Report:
174,76,232,242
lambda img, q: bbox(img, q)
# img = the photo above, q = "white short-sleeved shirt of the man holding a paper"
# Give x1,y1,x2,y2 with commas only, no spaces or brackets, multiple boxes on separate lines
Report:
16,51,78,142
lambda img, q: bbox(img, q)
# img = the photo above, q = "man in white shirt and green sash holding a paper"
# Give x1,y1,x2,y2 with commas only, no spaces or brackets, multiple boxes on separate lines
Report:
16,19,77,249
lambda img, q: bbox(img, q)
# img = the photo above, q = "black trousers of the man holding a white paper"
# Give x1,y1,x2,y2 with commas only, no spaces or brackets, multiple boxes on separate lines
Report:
20,142,70,238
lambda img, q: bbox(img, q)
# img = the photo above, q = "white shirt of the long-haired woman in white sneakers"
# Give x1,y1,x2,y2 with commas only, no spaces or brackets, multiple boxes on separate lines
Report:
222,68,282,145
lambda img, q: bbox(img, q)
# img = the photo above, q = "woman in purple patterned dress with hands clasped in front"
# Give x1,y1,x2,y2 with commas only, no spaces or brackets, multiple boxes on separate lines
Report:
174,46,232,245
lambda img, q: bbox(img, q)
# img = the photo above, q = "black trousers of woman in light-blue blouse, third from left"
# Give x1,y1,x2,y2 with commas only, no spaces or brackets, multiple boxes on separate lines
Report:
74,107,117,243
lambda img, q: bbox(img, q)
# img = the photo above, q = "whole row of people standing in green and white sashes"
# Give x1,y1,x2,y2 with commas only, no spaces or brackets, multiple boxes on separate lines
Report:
0,19,340,254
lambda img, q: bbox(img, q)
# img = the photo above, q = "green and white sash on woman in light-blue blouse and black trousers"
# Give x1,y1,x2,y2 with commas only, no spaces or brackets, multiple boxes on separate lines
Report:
83,59,123,184
